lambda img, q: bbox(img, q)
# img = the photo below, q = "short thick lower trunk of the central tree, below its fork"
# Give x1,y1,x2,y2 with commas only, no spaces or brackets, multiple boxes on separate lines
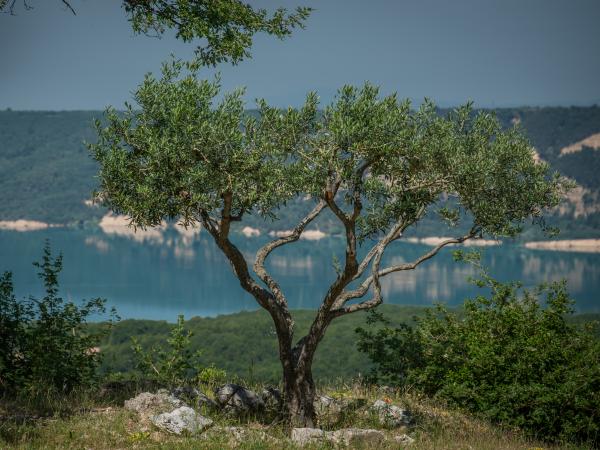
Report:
283,366,315,428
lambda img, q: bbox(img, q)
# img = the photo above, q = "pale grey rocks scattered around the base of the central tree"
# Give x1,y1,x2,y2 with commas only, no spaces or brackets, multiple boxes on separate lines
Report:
125,383,413,448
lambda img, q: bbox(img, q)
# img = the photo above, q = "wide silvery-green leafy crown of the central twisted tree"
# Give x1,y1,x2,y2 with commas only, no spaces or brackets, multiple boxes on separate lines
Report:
90,61,569,238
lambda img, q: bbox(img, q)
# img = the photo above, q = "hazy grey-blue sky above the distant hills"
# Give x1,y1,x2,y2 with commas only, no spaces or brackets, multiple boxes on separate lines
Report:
0,0,600,110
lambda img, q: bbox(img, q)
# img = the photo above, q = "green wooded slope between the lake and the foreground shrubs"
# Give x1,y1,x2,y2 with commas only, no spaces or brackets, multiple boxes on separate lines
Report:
91,305,600,383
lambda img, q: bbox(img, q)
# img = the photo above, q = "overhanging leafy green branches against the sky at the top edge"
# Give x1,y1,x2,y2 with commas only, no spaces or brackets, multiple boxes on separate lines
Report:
0,0,312,66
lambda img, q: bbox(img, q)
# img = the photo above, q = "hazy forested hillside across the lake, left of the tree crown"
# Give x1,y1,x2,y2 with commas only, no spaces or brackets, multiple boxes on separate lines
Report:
0,111,102,223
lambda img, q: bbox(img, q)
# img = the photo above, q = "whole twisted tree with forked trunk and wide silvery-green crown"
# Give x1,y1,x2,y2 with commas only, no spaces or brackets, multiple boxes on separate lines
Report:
90,61,568,426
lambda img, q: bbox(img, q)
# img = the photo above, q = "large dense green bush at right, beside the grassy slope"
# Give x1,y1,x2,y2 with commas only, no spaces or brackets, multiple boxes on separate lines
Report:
357,268,600,446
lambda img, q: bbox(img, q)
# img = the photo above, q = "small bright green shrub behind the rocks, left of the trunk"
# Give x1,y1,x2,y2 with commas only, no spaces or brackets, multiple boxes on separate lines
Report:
132,316,206,388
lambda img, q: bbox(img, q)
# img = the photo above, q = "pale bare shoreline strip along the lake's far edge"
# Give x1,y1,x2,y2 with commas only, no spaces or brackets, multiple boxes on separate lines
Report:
0,214,600,253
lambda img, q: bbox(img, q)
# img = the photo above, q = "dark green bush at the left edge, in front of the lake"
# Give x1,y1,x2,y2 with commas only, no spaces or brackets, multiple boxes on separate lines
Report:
0,244,115,398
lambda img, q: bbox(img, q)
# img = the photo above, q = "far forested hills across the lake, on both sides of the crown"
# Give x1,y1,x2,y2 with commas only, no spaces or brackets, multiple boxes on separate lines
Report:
0,106,600,237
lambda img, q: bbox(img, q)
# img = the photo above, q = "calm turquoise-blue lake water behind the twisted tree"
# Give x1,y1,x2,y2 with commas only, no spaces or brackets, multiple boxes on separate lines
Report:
0,229,600,321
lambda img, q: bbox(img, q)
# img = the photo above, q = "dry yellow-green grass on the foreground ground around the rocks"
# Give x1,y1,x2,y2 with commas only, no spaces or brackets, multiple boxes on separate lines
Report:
0,383,585,450
